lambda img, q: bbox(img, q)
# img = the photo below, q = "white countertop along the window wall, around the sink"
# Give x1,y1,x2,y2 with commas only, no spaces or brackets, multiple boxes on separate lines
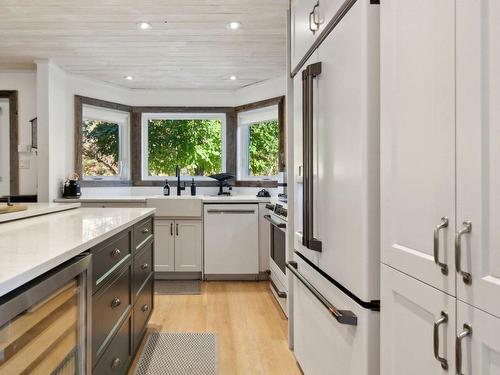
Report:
54,195,271,203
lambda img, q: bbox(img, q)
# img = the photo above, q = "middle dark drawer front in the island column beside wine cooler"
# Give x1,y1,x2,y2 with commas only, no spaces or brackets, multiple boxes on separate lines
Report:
92,265,132,362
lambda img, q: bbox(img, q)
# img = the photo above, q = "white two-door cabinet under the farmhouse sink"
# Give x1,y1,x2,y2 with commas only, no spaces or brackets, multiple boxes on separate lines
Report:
155,219,202,272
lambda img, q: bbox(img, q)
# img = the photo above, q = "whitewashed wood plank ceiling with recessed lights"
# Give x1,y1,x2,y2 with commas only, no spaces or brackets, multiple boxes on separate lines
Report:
0,0,288,89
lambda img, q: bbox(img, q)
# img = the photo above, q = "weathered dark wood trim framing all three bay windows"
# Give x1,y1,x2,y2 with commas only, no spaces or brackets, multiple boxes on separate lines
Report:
74,95,286,188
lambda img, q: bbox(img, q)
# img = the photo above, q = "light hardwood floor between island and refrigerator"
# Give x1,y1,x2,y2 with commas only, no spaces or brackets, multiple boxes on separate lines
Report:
129,281,300,375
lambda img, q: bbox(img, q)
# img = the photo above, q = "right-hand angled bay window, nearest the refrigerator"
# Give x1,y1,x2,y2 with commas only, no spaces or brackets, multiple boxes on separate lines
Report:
238,105,280,180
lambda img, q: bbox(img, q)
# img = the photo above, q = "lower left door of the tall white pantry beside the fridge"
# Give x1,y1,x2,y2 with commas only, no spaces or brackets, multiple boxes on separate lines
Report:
380,265,456,375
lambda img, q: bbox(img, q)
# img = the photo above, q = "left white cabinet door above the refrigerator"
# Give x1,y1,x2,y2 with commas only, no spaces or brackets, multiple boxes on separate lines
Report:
290,0,320,70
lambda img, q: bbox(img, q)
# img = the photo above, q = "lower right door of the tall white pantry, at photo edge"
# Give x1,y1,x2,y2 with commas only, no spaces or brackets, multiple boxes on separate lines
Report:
455,301,500,375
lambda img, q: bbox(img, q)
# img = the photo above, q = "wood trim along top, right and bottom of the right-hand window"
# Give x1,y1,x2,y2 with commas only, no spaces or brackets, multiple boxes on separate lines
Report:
234,95,286,187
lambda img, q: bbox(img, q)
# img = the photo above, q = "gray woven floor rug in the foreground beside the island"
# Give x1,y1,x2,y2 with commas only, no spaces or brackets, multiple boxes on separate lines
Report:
134,332,218,375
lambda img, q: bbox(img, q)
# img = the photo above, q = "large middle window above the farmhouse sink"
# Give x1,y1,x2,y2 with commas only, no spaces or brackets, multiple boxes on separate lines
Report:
142,113,226,180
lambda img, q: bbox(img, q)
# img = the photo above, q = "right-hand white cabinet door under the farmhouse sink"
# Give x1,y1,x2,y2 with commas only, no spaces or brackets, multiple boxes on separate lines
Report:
175,220,202,272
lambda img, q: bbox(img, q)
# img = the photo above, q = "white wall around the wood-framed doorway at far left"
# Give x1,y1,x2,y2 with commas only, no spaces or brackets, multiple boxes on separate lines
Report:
0,70,37,194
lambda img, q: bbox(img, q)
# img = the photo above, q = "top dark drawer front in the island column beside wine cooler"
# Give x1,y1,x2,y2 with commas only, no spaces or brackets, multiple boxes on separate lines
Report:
92,231,132,293
